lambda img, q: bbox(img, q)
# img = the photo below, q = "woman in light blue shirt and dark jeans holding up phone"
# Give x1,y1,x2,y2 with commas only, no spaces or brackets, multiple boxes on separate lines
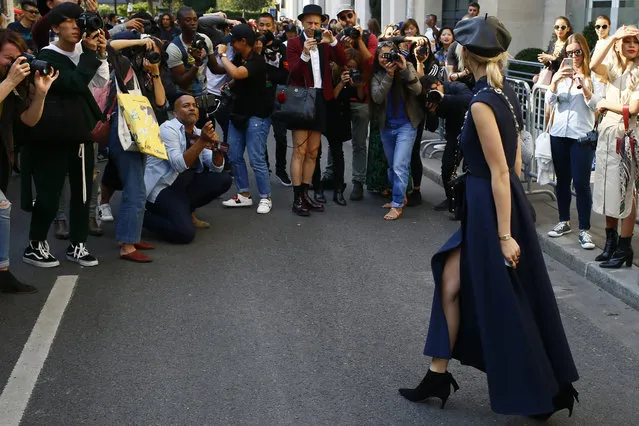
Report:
546,34,601,250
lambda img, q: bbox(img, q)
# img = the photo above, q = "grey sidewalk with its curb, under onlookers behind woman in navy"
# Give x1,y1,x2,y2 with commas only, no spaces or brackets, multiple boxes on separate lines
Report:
422,141,639,310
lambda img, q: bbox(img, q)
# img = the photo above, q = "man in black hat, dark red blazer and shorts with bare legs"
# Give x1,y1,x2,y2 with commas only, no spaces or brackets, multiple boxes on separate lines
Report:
286,4,346,216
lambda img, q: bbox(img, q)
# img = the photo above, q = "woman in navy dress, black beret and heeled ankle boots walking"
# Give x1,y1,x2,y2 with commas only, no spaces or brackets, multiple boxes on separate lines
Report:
399,17,579,420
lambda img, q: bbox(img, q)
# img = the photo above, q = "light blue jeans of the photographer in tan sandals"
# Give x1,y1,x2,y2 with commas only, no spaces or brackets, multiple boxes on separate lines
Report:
380,122,417,207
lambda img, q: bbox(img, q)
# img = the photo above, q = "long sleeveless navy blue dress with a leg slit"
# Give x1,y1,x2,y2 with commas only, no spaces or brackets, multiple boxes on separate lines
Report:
424,78,579,415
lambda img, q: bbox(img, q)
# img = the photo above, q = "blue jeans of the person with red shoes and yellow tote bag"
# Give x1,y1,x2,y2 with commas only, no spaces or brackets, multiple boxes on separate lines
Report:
109,114,146,244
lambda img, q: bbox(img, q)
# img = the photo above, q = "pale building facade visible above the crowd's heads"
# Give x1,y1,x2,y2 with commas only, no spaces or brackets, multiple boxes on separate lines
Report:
279,0,639,55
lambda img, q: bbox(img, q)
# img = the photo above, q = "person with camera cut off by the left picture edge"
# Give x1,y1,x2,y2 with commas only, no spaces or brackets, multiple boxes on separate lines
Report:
0,29,58,294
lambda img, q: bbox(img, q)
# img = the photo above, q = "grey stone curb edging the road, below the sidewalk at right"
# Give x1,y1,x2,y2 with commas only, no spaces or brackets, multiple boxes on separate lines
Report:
422,158,639,310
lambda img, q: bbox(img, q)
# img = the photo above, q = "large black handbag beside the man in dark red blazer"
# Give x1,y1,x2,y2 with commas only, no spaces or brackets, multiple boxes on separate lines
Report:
273,84,317,126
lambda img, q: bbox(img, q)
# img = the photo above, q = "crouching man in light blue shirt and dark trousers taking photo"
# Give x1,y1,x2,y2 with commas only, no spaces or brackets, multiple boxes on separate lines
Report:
144,95,231,244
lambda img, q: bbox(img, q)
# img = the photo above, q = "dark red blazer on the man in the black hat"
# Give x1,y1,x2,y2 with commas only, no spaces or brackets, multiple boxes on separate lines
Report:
286,34,346,101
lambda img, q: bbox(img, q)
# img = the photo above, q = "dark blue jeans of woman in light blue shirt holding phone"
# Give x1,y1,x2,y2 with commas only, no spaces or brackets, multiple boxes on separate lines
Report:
550,136,595,230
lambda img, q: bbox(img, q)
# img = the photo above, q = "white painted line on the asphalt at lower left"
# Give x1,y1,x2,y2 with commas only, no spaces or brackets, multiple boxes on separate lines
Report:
0,275,78,426
